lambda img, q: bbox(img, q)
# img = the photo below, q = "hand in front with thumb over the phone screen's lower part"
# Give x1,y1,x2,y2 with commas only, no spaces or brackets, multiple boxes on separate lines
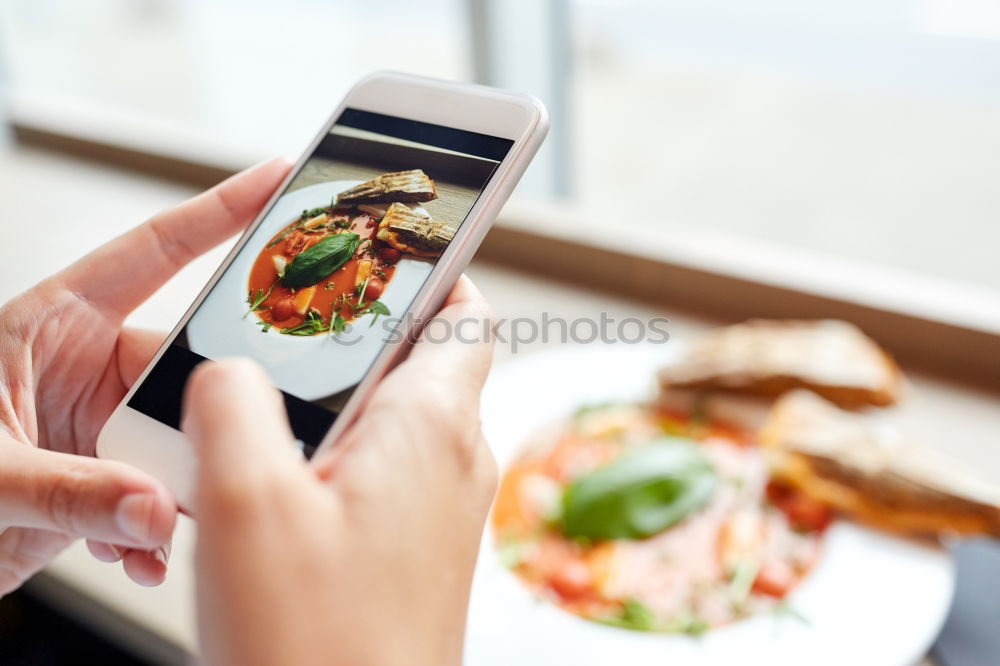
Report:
183,278,497,666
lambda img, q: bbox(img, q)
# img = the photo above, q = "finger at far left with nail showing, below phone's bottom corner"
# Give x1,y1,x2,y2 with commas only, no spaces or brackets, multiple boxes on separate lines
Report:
0,446,177,548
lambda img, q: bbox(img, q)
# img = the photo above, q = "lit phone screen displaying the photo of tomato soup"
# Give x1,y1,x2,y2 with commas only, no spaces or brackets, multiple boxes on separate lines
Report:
128,108,513,455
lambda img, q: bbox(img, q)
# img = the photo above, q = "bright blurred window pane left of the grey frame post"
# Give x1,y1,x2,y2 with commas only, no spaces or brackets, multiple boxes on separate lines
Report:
0,0,470,155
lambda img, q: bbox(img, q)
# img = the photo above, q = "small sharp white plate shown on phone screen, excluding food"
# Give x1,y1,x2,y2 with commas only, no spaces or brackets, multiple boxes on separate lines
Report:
187,180,434,400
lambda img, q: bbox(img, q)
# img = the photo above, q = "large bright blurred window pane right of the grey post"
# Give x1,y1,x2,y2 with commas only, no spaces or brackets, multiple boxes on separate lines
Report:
571,0,1000,295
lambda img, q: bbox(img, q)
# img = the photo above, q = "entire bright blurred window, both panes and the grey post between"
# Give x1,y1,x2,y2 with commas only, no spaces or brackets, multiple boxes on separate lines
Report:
0,0,1000,300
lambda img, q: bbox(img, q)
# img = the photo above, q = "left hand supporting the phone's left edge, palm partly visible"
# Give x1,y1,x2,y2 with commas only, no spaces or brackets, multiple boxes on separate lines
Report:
0,161,288,595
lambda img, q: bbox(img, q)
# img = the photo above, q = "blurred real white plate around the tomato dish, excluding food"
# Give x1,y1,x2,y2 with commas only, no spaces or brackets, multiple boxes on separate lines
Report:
466,342,955,666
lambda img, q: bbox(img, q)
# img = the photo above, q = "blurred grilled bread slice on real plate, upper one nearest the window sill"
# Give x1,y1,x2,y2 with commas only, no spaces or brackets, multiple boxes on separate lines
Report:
659,319,902,409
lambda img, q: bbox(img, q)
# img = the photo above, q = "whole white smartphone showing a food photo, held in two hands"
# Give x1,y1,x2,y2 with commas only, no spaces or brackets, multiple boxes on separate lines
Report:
97,73,548,512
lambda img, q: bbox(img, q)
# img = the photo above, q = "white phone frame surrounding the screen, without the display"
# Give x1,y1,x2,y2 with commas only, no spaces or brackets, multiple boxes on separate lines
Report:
97,72,548,513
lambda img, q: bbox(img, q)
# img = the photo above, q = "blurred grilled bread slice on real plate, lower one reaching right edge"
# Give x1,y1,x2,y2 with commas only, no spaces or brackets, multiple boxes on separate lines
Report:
760,391,1000,537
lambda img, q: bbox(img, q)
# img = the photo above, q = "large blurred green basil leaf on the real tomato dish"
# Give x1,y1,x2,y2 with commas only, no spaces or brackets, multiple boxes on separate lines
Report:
560,437,716,540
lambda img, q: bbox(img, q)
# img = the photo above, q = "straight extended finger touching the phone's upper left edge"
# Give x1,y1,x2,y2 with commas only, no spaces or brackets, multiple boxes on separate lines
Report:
57,160,290,318
